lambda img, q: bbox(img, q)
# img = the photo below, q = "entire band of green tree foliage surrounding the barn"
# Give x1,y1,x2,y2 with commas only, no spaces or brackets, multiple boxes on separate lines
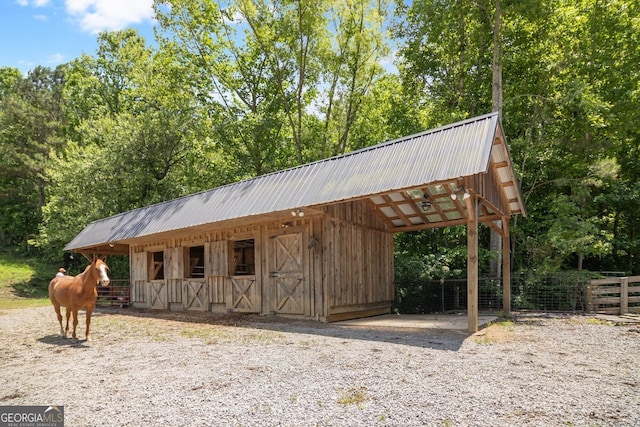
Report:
0,0,640,277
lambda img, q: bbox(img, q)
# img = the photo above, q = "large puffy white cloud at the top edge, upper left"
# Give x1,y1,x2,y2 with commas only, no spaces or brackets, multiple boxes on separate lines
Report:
64,0,153,34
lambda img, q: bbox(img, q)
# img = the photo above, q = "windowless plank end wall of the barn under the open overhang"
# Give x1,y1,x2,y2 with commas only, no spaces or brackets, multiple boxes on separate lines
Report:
324,202,393,321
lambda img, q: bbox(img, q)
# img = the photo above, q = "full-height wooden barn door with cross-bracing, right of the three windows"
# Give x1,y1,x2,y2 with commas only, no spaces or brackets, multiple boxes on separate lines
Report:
268,233,306,315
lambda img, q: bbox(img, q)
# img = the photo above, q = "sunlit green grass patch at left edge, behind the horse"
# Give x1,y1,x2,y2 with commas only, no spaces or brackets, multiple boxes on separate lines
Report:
0,248,56,309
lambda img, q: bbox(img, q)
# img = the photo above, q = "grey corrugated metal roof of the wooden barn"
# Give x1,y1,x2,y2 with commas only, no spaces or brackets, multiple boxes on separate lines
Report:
65,113,524,254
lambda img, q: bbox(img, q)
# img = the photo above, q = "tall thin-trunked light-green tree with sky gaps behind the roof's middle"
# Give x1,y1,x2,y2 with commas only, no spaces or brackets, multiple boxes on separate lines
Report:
155,0,388,171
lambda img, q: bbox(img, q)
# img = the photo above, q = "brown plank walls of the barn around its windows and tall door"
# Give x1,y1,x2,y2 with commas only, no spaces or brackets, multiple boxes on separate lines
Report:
131,201,393,320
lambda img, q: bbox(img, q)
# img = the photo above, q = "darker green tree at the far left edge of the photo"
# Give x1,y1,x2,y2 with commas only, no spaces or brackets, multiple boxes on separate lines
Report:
0,66,65,249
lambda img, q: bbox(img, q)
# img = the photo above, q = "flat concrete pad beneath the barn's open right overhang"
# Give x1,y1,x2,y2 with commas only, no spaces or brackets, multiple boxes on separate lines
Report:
334,313,498,331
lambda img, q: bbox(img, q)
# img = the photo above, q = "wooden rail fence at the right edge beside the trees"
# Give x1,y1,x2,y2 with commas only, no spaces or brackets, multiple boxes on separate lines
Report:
587,276,640,314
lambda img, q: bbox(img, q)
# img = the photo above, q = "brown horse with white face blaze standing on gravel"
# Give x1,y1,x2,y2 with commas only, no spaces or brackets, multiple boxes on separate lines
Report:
49,257,109,341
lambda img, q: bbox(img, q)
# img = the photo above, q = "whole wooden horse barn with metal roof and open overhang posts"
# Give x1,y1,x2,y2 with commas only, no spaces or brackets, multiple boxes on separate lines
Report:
65,113,525,331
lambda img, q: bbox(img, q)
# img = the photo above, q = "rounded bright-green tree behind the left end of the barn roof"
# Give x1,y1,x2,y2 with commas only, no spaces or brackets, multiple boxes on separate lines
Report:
40,30,229,258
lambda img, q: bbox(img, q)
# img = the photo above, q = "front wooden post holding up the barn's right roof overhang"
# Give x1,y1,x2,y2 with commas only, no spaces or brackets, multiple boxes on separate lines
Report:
465,193,478,333
